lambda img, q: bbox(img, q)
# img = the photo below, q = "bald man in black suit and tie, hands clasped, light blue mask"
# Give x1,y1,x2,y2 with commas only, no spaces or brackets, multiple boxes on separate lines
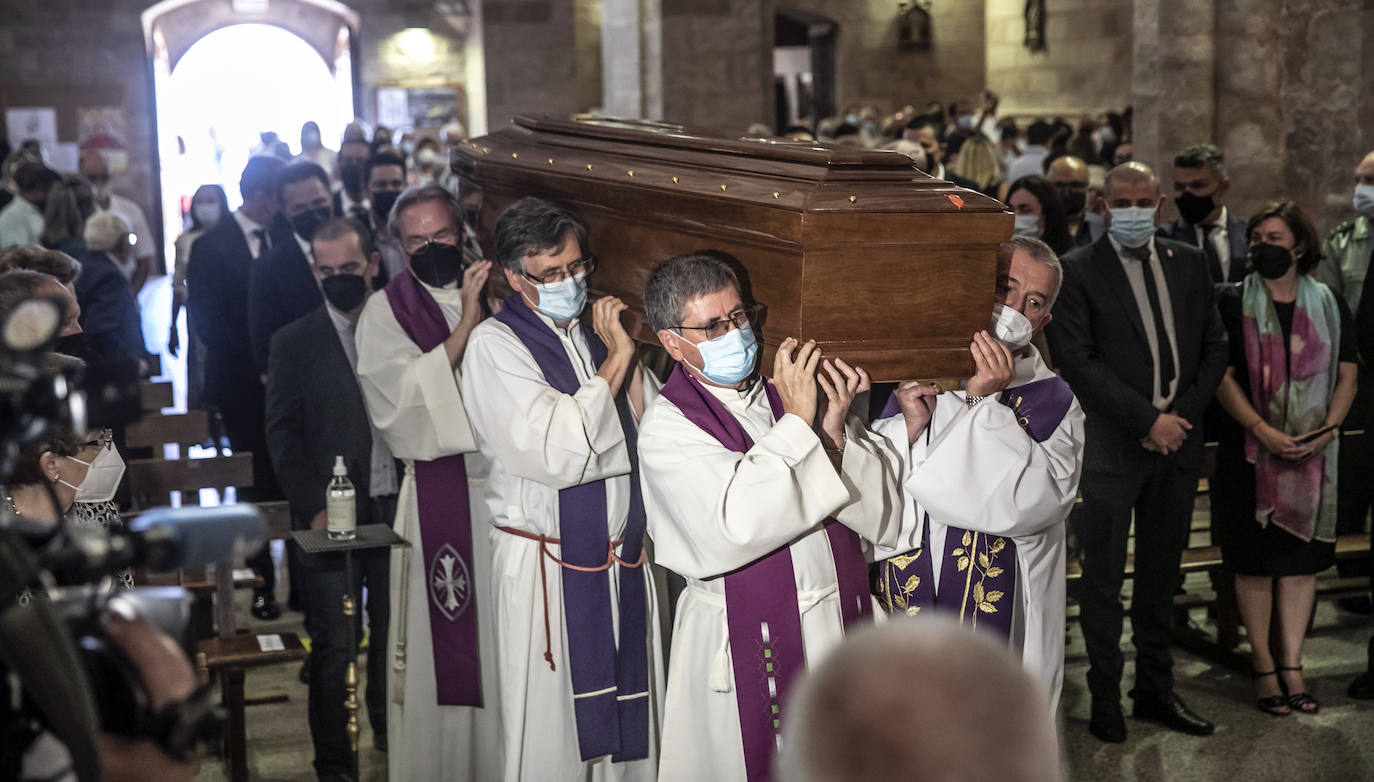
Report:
1047,162,1227,741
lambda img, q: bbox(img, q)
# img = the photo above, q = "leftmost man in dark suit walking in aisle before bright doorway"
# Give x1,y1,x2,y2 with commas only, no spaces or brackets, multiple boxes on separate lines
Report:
187,155,289,620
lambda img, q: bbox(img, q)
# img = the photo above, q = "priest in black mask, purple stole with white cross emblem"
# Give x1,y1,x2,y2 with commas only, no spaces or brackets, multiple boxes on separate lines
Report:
357,184,502,782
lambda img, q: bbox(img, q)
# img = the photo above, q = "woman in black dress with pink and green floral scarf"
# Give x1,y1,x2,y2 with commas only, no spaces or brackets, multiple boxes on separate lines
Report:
1212,202,1356,716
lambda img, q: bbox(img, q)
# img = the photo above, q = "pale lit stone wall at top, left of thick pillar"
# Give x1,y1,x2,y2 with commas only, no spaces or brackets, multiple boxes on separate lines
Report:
985,0,1151,118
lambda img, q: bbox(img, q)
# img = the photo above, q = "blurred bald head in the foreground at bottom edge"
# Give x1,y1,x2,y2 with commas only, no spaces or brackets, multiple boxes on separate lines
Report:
780,617,1059,782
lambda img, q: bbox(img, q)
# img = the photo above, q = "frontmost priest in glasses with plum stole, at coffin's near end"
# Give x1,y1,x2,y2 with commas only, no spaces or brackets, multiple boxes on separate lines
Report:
639,253,901,782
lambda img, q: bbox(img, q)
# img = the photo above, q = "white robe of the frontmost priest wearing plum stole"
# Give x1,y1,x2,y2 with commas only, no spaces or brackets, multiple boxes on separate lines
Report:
639,373,901,782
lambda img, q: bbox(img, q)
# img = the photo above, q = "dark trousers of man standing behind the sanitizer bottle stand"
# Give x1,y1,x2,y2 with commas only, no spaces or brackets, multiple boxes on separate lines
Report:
301,495,396,778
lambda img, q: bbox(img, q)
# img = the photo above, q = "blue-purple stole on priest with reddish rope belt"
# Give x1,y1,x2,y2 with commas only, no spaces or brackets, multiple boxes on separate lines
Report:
495,293,649,763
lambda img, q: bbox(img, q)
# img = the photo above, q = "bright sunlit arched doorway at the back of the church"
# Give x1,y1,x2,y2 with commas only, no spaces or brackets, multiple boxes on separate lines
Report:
140,0,357,407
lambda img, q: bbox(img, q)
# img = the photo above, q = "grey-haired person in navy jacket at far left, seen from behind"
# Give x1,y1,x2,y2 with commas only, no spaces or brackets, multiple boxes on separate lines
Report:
76,212,148,377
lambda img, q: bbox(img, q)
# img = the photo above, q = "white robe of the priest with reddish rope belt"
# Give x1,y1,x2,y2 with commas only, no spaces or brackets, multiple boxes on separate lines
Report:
462,311,664,782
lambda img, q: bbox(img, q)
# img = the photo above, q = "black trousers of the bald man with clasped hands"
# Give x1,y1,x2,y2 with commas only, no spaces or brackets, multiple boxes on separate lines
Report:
1077,455,1198,701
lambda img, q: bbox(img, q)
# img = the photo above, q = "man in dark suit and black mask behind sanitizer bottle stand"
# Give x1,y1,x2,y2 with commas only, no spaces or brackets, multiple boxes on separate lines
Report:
267,219,398,779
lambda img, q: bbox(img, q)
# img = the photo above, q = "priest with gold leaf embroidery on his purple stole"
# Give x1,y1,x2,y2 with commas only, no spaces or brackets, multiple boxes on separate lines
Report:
872,236,1083,713
